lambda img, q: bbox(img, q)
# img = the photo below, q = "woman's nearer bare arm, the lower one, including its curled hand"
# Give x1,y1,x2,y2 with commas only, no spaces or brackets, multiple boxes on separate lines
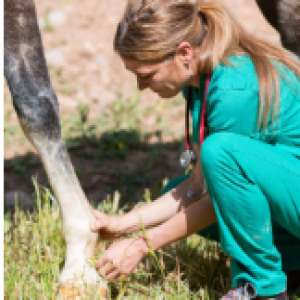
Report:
96,195,216,280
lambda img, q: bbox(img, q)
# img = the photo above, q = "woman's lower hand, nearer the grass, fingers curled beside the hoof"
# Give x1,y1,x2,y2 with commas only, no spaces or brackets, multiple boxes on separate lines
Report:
96,237,149,280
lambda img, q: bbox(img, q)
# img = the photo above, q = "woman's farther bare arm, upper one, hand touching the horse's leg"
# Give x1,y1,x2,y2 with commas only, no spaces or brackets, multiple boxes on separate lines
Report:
91,143,203,240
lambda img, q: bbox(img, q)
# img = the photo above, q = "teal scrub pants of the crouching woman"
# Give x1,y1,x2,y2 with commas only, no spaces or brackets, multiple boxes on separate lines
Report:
163,132,300,296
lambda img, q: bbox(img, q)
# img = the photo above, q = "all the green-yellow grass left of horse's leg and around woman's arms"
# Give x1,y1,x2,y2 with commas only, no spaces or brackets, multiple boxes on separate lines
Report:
4,181,230,299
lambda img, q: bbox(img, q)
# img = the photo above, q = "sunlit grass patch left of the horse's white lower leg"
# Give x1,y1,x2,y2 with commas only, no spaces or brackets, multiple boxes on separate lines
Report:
4,183,65,299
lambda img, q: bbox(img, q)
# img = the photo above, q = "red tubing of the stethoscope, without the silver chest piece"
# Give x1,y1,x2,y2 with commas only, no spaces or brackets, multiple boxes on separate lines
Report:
185,74,211,150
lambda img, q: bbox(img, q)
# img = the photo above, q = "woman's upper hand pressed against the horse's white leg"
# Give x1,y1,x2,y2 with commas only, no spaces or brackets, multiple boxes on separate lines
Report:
90,210,123,240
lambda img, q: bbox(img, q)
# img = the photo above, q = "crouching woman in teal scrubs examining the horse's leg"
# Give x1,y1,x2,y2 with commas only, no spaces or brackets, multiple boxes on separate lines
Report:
91,0,300,299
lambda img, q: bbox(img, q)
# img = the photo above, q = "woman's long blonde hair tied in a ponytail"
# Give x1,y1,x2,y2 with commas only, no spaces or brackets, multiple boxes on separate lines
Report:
114,0,300,129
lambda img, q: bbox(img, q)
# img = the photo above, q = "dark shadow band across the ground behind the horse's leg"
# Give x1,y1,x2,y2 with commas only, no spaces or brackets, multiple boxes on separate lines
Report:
4,130,184,213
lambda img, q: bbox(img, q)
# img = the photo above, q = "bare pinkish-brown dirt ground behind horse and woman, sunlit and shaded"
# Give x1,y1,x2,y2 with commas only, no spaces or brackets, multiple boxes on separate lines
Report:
4,0,279,206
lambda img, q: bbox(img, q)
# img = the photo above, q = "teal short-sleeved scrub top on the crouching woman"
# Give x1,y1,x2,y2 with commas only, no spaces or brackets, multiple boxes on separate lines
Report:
183,55,300,158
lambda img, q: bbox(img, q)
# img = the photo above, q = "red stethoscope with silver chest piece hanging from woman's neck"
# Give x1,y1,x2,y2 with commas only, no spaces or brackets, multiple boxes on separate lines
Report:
179,74,211,170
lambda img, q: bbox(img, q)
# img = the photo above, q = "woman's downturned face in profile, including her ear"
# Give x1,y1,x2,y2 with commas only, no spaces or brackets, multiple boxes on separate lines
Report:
122,42,196,98
